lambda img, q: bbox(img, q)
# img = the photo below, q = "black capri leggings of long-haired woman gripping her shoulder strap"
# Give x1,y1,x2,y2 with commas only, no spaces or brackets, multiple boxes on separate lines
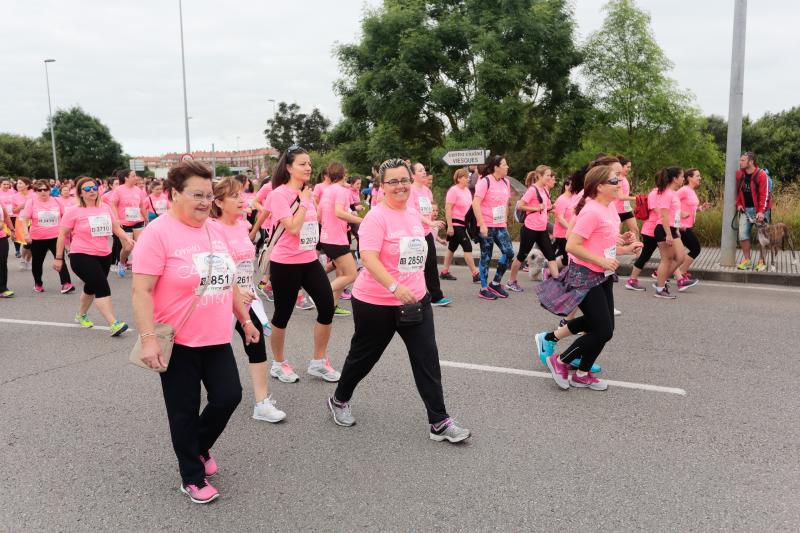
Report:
269,259,333,329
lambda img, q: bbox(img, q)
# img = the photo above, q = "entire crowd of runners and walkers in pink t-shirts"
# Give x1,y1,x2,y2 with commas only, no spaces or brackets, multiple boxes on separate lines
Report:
0,149,768,503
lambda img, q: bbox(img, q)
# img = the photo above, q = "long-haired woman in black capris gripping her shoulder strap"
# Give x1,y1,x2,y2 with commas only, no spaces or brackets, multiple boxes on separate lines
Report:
266,145,339,383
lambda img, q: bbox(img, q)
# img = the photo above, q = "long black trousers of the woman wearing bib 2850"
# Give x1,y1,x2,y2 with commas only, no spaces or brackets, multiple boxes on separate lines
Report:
334,298,448,424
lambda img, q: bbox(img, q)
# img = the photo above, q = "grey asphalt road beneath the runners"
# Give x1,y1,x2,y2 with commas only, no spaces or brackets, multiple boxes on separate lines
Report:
0,259,800,531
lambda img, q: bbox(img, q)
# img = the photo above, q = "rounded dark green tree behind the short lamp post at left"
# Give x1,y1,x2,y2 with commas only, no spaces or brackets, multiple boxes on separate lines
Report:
42,106,127,178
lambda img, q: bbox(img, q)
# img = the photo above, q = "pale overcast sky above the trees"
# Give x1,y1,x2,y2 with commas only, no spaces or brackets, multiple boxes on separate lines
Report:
0,0,800,155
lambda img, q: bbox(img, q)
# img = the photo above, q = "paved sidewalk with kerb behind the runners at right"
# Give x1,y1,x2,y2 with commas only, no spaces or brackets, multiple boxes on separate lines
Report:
436,242,800,287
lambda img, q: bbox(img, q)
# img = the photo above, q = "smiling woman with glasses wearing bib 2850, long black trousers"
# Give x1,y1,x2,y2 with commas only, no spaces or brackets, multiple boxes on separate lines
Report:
328,159,470,442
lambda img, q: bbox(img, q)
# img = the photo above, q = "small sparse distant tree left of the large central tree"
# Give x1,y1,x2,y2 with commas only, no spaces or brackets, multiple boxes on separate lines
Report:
264,102,331,152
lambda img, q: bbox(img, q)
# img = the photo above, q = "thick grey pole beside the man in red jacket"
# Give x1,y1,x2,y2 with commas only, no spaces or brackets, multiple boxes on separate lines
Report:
720,0,747,267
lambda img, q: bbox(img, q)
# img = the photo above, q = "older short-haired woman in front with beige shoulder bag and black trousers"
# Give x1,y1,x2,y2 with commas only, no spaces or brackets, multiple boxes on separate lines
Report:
133,161,260,503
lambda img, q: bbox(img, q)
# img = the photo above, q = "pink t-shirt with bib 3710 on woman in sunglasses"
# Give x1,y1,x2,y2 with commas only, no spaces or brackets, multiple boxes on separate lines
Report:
61,202,115,257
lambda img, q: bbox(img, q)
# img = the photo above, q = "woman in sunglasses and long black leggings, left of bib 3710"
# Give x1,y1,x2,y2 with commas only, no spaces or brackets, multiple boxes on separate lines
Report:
20,180,75,294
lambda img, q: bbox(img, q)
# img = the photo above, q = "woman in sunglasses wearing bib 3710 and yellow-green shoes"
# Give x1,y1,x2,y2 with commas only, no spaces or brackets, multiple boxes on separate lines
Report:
53,176,133,337
